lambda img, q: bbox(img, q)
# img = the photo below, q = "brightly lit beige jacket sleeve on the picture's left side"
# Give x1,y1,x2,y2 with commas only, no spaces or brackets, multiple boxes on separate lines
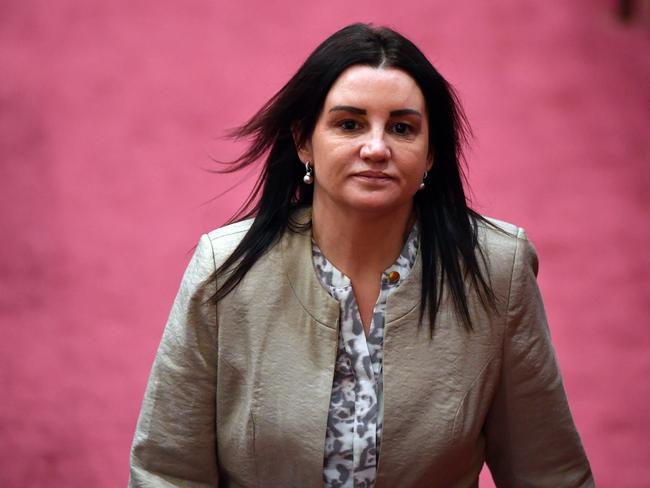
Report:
129,235,218,488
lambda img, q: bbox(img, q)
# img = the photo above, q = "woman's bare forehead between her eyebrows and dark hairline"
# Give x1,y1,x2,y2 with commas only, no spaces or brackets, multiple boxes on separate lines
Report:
325,66,425,112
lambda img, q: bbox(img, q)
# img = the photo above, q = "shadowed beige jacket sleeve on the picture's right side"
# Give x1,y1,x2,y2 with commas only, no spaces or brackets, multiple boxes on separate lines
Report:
485,229,594,488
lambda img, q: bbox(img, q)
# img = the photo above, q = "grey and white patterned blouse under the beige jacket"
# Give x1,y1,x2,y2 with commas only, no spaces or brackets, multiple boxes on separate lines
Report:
312,224,419,488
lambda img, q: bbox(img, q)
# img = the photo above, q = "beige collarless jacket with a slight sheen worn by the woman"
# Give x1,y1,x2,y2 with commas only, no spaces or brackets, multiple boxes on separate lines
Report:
129,208,594,488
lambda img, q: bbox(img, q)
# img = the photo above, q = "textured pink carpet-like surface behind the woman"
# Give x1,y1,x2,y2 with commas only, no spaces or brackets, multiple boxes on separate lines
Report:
0,0,650,488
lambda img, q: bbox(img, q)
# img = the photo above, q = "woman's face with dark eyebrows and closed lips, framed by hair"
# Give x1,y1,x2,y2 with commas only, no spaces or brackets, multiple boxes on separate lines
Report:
299,66,431,213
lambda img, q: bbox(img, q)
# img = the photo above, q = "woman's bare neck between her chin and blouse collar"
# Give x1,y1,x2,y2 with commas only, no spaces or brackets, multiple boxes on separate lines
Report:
312,199,415,277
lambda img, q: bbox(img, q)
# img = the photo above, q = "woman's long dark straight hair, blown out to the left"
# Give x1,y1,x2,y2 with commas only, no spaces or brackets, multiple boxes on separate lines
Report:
213,24,495,330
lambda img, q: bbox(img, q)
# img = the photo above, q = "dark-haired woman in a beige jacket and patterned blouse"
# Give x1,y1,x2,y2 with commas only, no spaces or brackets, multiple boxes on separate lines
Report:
130,24,593,487
